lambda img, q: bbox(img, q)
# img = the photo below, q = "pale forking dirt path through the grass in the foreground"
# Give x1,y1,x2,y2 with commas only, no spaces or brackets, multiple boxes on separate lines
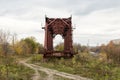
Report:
20,59,92,80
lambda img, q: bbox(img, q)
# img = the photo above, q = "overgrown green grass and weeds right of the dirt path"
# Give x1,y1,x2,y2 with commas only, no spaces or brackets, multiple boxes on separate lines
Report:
29,53,120,80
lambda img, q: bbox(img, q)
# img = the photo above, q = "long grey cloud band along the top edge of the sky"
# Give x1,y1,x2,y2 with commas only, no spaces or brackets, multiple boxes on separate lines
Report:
0,0,120,15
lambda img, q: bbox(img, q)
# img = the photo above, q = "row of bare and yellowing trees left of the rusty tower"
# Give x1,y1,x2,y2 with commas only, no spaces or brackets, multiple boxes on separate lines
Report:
0,30,43,55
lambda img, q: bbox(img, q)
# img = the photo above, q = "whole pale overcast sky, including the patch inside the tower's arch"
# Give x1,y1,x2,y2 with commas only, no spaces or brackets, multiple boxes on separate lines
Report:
0,0,120,46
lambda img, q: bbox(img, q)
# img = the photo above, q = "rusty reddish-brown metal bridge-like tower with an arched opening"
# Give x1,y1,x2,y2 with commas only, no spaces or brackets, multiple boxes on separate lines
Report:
43,17,74,57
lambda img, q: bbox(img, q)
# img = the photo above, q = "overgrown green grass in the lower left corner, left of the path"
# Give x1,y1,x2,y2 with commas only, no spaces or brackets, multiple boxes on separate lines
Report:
0,55,34,80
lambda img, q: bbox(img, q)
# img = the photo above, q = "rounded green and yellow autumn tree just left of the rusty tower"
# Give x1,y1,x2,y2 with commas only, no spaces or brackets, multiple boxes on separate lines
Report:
15,37,43,54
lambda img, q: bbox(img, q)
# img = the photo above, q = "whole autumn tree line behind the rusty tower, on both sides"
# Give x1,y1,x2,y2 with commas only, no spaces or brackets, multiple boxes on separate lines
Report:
0,30,120,63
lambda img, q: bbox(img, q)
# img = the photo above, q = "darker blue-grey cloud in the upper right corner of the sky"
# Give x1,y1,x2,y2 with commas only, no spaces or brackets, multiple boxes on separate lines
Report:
74,0,120,15
